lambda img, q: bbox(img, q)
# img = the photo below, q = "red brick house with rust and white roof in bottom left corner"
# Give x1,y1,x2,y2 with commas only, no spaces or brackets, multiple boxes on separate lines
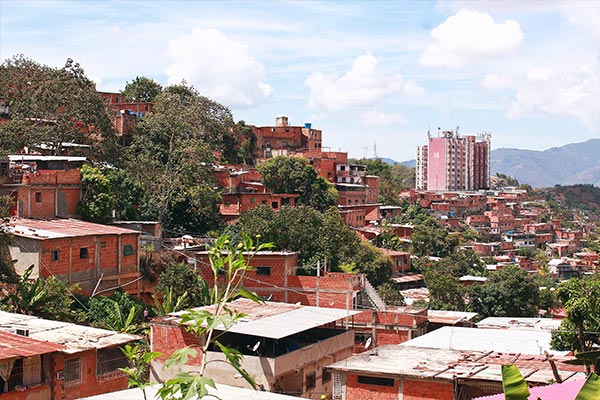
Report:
0,311,140,400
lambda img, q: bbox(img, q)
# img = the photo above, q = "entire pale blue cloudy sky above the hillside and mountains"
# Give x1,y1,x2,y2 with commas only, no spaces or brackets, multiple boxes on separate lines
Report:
0,0,600,161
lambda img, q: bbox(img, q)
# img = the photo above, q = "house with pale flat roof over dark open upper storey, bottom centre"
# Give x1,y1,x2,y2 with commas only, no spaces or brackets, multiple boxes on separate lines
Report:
150,299,357,399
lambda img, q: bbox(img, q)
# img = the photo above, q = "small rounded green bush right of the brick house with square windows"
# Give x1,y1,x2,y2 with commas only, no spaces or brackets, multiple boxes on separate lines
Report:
156,263,211,308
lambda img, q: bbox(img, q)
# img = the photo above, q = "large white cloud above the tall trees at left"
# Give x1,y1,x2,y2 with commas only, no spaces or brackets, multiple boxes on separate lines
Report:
165,28,273,107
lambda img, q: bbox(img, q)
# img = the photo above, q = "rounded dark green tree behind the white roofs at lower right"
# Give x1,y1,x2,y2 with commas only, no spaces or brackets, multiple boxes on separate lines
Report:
469,265,539,318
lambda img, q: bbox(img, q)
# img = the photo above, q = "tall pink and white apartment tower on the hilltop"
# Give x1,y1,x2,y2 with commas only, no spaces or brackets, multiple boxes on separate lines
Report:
415,131,491,191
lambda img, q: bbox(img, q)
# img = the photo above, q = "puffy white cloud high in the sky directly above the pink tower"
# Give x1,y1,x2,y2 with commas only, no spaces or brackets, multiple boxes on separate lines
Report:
420,9,523,67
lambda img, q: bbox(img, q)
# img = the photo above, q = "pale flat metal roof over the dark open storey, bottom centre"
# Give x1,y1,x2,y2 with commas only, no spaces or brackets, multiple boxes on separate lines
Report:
158,299,362,339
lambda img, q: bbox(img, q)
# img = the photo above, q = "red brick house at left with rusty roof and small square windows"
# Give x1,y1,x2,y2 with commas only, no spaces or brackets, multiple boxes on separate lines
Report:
8,218,141,296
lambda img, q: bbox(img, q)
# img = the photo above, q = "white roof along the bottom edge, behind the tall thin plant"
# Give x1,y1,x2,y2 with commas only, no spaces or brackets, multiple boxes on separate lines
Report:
80,383,304,400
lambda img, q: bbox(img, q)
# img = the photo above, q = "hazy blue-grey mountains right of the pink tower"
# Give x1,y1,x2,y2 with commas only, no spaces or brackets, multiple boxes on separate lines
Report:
490,139,600,187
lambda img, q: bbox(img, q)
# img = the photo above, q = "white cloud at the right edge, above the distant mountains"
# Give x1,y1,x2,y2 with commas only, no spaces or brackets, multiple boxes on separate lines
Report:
508,65,600,132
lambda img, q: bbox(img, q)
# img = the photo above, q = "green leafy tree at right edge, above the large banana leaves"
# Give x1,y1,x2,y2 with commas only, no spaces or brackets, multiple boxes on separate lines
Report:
552,273,600,351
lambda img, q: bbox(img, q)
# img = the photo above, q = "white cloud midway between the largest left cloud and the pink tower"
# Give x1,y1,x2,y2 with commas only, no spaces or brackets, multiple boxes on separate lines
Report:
305,53,402,110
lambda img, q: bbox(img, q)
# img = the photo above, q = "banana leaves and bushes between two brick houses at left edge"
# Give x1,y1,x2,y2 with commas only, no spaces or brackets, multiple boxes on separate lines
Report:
0,265,83,322
